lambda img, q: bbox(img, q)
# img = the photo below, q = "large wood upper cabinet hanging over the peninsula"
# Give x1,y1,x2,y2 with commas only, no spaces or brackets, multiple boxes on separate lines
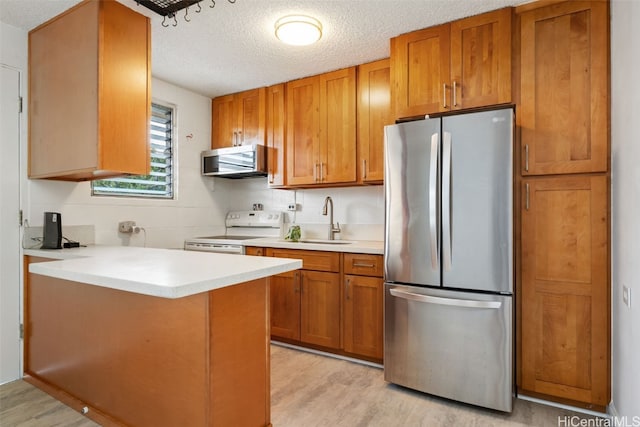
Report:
28,0,151,181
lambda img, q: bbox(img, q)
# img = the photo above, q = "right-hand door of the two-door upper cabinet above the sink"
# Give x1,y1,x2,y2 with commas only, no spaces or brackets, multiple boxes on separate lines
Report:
319,67,356,183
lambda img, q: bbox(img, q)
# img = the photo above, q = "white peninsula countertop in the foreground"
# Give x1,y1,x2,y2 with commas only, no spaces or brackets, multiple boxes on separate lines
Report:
24,246,302,298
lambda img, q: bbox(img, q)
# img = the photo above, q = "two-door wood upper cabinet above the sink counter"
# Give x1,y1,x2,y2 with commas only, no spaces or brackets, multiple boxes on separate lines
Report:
286,67,356,186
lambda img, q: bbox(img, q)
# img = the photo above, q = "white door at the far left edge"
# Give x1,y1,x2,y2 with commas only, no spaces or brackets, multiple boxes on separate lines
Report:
0,65,22,384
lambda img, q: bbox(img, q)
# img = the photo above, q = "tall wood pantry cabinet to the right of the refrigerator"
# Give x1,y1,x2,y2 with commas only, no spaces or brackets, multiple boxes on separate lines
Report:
516,1,611,410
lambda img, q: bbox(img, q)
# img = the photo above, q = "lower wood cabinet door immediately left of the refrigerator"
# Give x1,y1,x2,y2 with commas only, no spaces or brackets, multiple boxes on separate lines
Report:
344,275,383,359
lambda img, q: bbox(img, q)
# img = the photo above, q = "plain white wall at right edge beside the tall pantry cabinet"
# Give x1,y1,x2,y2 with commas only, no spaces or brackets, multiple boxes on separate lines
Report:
611,0,640,417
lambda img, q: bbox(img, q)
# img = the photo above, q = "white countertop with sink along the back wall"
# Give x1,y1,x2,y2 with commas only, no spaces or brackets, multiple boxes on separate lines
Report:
243,237,384,255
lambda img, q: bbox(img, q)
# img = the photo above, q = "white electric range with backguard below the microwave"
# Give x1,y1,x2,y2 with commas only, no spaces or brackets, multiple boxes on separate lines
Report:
184,211,284,255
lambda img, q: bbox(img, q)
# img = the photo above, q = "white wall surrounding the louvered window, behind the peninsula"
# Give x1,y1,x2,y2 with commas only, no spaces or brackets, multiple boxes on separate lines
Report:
26,78,235,248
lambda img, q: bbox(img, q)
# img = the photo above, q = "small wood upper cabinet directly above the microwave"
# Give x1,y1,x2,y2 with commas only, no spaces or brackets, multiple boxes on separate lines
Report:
211,88,267,148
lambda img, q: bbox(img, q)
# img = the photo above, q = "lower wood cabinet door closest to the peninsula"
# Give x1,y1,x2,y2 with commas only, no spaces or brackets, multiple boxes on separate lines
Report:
269,271,300,340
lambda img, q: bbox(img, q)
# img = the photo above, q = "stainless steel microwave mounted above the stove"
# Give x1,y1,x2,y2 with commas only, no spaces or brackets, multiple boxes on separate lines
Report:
200,144,267,178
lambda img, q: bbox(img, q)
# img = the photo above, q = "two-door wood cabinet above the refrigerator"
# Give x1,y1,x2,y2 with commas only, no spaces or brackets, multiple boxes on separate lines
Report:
391,8,512,118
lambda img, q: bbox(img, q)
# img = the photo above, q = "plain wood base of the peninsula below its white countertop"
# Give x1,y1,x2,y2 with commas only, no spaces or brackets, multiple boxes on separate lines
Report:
25,264,270,427
